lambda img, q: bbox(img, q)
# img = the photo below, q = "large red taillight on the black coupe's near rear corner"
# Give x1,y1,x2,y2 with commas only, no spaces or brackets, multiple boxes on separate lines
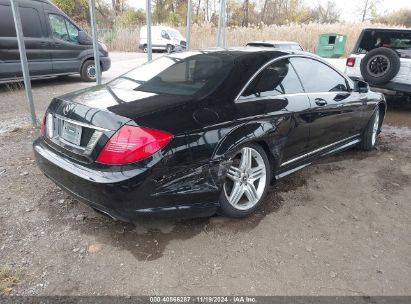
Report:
97,126,173,165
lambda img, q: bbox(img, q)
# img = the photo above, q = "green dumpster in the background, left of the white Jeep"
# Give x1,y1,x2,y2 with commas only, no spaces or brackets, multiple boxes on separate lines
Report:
317,33,347,58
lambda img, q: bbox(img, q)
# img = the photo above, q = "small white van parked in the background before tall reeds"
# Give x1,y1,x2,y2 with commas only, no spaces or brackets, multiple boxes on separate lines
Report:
139,26,187,53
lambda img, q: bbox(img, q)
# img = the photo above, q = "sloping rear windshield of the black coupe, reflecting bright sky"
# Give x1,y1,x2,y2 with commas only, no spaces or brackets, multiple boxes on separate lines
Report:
111,53,233,96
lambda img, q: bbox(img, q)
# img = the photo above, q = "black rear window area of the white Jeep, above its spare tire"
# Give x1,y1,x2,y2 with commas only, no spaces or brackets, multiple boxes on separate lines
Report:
355,30,411,54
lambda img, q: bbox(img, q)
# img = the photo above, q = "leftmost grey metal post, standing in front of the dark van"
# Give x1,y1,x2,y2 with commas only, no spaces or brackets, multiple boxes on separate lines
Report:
10,0,37,127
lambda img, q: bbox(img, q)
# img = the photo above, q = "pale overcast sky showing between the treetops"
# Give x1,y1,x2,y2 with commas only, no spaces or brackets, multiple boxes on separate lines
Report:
128,0,411,21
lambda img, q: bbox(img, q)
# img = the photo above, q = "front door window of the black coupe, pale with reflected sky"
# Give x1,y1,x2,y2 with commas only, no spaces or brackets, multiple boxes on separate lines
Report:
291,58,348,93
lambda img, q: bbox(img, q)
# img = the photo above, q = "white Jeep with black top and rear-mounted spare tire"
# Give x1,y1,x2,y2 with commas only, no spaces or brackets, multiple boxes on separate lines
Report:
345,28,411,100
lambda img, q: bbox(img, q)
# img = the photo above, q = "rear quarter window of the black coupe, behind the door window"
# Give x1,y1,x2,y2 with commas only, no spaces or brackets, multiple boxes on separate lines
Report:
241,59,304,97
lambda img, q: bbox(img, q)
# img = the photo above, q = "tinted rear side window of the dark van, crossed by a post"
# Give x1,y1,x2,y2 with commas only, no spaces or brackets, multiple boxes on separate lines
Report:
0,5,43,38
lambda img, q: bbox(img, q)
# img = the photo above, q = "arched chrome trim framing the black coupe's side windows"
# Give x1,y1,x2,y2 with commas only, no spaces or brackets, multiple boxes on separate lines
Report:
234,54,352,103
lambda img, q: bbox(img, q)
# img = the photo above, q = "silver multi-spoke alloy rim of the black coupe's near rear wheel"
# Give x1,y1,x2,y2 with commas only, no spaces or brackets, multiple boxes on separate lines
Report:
224,147,267,210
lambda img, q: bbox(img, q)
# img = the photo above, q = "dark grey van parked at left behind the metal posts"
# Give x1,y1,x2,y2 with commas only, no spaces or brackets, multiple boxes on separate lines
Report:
0,0,111,82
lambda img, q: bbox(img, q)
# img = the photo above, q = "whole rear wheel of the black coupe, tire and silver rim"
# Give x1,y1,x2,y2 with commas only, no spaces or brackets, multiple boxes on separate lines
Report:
219,144,271,218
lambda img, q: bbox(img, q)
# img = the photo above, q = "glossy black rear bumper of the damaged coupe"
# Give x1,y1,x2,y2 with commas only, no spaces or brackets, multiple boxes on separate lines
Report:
33,138,219,221
